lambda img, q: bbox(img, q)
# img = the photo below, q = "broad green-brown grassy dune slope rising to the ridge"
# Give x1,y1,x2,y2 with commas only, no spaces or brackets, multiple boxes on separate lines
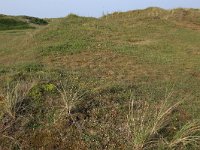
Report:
0,8,200,149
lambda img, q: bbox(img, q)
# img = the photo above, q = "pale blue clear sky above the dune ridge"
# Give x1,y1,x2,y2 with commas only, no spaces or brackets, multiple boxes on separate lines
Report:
0,0,200,18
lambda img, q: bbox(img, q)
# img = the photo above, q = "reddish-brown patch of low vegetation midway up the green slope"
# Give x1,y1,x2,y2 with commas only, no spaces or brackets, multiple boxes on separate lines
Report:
44,51,153,80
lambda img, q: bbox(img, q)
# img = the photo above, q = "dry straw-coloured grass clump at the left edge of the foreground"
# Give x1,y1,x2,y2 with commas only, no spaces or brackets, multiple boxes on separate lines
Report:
0,81,35,149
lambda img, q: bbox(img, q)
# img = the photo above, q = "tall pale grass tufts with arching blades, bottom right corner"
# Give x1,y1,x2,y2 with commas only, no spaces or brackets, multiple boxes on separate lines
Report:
127,94,200,150
